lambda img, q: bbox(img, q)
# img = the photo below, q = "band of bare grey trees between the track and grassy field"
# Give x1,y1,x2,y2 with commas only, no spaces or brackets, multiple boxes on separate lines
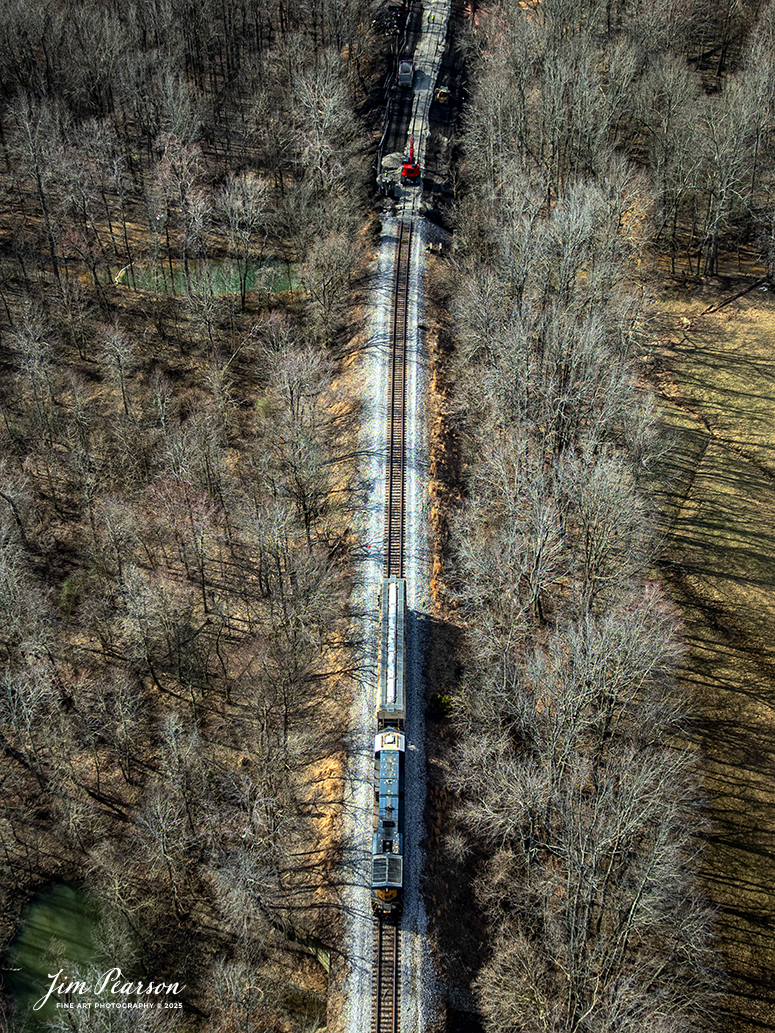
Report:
434,0,775,1033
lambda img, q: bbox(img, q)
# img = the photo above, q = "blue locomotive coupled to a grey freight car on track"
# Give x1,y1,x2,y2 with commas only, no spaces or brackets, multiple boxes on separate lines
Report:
371,577,406,917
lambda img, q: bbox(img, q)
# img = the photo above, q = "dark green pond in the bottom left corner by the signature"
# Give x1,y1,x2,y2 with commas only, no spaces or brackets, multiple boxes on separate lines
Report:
4,883,97,1028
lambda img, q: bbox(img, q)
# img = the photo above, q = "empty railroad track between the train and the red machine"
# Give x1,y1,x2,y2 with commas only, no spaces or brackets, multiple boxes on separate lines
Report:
384,221,412,577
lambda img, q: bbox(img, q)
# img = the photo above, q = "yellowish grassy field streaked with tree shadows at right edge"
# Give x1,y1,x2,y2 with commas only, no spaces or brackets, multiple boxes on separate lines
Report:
648,278,775,1033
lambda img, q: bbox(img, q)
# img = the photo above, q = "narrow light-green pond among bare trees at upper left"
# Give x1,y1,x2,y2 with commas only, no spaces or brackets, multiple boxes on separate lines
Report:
116,258,299,294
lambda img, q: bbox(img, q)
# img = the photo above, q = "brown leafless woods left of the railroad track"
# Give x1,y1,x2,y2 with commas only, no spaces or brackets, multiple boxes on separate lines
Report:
0,0,380,1030
